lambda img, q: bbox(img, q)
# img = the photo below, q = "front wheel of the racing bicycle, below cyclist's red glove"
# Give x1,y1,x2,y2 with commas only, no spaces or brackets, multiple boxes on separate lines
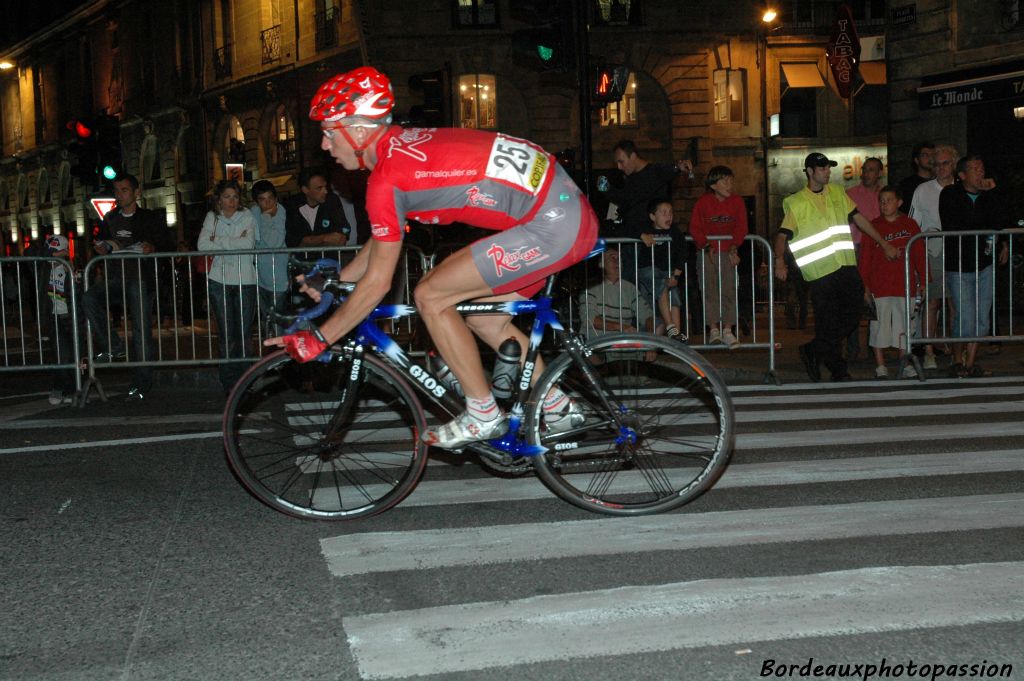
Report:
224,351,427,520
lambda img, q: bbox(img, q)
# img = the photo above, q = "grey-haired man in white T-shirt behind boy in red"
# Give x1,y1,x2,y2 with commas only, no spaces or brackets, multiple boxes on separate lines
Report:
904,145,958,369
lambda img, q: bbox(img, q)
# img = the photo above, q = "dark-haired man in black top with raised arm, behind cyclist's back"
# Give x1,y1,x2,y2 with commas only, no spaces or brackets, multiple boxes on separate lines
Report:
602,139,693,282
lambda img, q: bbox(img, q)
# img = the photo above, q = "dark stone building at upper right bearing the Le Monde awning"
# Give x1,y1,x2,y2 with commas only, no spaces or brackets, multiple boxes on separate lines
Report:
886,0,1024,219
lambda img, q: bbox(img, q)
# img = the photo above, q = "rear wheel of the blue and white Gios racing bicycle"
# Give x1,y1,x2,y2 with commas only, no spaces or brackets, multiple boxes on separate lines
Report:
527,334,735,515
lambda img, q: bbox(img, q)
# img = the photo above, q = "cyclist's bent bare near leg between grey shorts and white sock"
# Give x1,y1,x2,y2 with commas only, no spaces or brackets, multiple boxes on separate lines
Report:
414,247,492,399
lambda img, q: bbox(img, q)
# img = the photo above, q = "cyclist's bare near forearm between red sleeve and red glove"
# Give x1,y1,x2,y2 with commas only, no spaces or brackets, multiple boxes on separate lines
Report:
319,240,401,343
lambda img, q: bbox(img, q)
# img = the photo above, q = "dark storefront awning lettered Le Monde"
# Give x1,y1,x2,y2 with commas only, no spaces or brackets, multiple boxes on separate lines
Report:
918,61,1024,110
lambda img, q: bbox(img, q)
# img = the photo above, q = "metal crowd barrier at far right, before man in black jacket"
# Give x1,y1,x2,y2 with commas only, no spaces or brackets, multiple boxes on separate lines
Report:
903,227,1024,380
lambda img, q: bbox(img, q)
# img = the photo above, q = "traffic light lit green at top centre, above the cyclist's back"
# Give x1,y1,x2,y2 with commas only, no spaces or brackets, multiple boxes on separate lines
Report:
511,0,575,71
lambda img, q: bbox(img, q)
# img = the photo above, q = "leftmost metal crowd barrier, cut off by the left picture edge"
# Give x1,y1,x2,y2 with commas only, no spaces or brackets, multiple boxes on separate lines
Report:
0,257,82,394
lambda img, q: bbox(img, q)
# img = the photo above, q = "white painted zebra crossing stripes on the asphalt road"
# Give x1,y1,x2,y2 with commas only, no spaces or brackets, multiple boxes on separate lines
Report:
309,380,1024,679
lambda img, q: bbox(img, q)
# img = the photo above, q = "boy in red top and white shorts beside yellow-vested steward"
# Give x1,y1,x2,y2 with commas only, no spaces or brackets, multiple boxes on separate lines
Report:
860,186,927,378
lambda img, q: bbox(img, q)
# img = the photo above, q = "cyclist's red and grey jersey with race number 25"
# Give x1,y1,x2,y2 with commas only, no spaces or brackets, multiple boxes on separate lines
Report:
367,126,556,242
